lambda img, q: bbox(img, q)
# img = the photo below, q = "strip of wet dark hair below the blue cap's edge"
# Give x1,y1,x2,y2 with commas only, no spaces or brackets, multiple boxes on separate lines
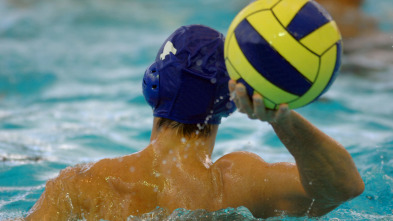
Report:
157,117,213,137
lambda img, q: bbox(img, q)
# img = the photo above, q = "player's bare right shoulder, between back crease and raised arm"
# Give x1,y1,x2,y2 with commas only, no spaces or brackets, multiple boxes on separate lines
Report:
214,151,308,217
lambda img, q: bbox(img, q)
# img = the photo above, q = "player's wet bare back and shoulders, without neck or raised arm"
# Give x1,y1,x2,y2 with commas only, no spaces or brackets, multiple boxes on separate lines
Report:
26,149,309,220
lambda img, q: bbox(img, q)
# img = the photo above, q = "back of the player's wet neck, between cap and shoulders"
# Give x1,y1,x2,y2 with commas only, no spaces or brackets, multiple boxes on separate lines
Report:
148,119,218,159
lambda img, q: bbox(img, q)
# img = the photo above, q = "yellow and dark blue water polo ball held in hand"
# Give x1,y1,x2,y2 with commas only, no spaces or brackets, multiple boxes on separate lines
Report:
224,0,342,109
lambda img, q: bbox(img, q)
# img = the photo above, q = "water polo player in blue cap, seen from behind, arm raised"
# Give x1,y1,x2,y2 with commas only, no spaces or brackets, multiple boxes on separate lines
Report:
27,25,364,220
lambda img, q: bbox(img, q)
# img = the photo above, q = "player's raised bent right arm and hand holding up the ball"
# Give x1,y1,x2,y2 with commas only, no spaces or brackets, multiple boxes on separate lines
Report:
229,81,364,216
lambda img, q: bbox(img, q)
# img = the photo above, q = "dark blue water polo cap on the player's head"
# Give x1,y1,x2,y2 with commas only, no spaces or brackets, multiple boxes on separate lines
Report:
143,25,236,124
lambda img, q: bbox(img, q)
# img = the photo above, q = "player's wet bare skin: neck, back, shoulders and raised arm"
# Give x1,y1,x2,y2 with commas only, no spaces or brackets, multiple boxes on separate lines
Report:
27,81,364,220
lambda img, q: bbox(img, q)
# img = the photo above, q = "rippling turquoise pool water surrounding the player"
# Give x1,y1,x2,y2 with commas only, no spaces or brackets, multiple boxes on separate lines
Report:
0,0,393,220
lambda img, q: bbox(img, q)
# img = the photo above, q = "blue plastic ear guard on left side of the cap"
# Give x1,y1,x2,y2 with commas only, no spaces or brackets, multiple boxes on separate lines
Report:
142,62,160,110
